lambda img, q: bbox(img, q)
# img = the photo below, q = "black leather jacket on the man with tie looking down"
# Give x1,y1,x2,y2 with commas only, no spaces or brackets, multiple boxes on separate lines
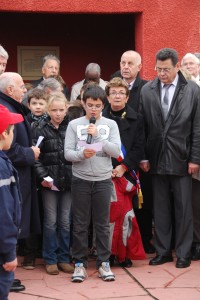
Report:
141,72,200,176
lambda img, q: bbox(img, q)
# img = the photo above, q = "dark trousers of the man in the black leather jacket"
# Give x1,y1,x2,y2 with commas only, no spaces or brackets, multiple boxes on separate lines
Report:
152,175,193,258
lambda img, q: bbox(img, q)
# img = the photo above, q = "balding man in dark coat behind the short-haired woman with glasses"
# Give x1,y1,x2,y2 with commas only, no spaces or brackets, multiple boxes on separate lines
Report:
111,50,155,253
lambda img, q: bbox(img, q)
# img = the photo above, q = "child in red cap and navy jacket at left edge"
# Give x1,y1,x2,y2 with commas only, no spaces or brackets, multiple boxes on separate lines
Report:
0,105,23,300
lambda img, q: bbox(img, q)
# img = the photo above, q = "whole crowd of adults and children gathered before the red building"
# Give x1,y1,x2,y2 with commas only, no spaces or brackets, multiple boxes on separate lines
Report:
0,46,200,300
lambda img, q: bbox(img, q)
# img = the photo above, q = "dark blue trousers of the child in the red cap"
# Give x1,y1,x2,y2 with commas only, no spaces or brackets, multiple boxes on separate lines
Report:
0,266,14,300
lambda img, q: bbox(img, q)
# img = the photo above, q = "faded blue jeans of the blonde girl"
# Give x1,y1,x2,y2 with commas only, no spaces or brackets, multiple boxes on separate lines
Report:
42,189,71,265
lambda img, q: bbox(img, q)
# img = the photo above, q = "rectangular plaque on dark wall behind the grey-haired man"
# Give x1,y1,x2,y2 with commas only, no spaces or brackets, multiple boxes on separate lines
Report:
17,46,60,80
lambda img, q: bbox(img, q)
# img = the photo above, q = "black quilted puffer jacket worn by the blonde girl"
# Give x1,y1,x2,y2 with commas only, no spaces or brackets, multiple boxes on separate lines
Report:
32,117,72,191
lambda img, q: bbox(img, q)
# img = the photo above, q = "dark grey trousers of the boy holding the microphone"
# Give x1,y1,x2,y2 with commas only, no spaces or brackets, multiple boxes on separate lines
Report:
72,176,112,268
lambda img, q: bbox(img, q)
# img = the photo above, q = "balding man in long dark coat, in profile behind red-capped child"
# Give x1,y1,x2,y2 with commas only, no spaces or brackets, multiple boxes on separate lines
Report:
0,72,40,291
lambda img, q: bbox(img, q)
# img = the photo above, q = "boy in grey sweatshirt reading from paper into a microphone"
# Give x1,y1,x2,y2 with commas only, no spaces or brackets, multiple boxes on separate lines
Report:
64,86,121,282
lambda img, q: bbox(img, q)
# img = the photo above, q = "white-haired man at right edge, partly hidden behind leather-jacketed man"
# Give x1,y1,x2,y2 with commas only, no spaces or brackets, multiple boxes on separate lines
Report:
181,53,200,86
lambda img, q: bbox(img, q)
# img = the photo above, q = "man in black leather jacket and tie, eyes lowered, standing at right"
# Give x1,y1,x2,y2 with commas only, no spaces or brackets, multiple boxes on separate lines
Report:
140,48,200,268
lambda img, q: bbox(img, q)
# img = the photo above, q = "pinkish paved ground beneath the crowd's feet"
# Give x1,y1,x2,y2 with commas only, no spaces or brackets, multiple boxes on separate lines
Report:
9,253,200,300
